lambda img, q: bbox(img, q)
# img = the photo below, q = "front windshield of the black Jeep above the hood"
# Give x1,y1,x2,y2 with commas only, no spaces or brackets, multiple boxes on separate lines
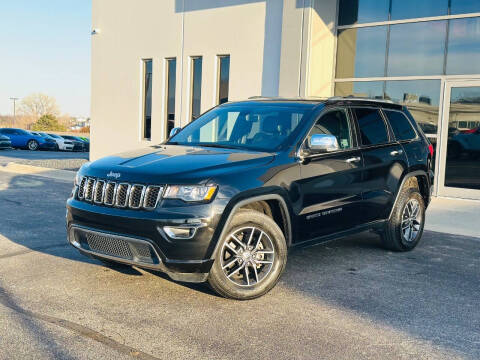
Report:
168,103,314,151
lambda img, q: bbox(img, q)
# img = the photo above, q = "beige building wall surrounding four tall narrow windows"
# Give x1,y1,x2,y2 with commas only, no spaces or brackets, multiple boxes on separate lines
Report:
91,0,336,159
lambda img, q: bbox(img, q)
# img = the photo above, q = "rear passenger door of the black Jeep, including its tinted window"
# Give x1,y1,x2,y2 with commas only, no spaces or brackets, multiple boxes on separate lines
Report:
351,106,408,223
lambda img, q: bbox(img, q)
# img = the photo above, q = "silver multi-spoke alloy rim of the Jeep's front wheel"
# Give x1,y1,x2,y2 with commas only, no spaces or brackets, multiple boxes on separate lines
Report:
221,227,275,286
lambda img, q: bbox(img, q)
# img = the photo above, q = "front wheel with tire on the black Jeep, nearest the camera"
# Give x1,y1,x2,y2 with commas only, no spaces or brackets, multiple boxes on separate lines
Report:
208,210,287,300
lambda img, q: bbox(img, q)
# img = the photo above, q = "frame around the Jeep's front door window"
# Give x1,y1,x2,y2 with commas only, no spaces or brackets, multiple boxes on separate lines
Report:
297,105,359,158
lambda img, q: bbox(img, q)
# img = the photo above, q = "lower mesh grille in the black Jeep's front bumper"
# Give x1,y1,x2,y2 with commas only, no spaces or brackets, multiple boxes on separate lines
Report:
70,227,161,265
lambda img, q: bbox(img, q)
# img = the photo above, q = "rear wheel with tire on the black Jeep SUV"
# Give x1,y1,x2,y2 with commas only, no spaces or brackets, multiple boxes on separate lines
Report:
381,186,425,251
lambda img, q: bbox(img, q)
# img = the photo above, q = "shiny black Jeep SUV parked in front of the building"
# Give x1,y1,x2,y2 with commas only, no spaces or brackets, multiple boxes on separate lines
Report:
67,98,433,299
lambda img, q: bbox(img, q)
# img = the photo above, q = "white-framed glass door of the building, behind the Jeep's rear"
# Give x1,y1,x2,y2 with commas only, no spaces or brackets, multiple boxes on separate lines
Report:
437,80,480,199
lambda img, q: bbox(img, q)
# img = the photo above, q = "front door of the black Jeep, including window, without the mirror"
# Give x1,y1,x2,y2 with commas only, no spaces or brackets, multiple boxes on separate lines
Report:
298,107,363,240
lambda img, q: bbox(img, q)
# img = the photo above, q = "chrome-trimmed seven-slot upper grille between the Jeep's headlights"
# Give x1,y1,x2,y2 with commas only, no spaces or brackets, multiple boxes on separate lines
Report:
77,177,163,210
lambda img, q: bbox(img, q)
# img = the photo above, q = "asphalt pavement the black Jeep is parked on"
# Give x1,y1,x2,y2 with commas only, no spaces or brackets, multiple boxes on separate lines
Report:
0,172,480,360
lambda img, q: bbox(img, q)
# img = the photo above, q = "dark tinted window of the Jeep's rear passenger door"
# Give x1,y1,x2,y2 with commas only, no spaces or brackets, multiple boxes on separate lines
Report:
353,108,389,145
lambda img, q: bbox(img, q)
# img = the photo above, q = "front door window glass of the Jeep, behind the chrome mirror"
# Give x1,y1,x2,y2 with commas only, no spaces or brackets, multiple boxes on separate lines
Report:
309,109,352,149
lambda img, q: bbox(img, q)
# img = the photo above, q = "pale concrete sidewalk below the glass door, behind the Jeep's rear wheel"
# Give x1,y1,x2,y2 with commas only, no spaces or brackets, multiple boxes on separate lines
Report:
425,197,480,238
